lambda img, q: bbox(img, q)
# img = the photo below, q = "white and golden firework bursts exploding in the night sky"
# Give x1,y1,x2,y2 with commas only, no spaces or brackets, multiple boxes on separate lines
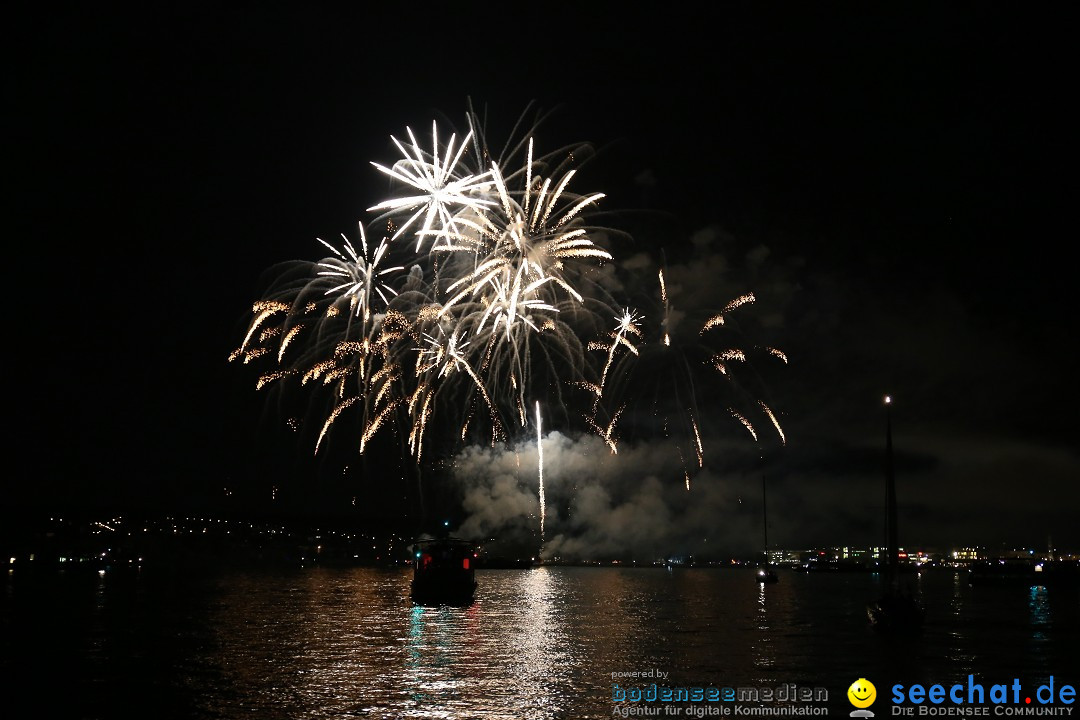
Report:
229,104,786,492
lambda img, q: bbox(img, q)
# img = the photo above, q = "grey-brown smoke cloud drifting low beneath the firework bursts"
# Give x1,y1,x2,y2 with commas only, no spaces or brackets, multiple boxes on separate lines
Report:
455,432,762,562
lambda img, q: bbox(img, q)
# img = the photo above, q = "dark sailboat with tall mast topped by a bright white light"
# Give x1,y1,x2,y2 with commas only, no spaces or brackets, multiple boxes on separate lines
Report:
866,396,926,633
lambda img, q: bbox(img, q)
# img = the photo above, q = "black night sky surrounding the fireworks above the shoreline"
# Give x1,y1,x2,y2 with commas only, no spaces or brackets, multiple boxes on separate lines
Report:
12,3,1080,549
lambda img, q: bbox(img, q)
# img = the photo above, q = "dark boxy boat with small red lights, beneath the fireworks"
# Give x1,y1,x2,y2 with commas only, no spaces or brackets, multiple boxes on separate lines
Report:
410,533,476,608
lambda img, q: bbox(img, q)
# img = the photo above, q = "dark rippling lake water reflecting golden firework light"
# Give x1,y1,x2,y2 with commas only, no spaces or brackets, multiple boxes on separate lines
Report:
2,567,1080,720
